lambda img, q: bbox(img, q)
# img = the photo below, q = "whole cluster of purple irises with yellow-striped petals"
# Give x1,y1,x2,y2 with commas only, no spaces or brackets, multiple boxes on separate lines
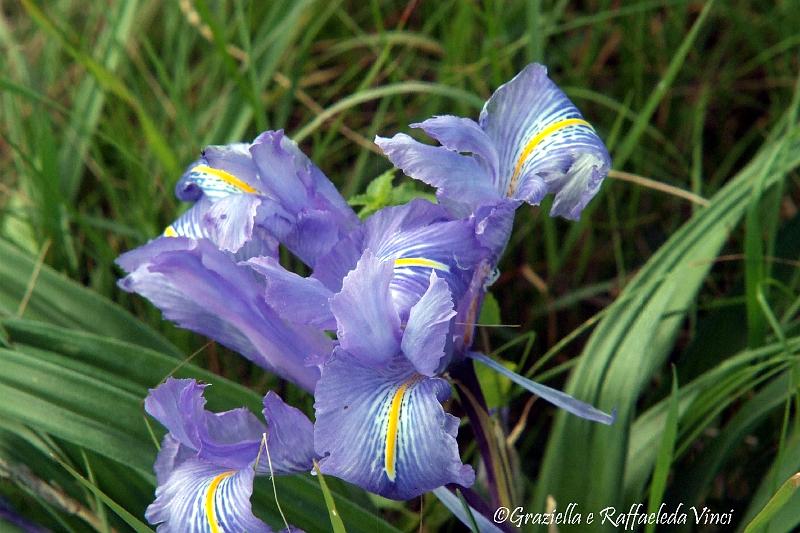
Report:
118,65,612,531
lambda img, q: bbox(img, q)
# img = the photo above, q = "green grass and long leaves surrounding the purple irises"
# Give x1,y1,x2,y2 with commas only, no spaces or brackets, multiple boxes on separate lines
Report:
0,0,800,532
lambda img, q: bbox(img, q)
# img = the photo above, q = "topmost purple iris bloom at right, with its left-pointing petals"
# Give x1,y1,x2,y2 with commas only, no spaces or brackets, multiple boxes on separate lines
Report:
375,64,611,254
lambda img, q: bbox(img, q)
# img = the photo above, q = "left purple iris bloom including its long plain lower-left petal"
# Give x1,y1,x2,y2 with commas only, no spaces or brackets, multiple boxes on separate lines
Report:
117,131,359,391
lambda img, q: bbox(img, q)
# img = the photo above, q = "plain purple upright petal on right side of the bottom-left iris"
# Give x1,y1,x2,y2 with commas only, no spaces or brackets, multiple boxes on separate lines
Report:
257,391,316,474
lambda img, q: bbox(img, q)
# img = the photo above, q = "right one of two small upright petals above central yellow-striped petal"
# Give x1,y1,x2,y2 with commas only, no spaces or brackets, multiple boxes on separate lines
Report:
400,272,456,376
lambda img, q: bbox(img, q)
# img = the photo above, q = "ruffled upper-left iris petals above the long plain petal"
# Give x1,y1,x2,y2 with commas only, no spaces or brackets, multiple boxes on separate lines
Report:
164,131,358,267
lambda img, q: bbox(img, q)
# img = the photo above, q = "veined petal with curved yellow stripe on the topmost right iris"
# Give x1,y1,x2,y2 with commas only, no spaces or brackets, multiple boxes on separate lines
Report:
480,64,611,218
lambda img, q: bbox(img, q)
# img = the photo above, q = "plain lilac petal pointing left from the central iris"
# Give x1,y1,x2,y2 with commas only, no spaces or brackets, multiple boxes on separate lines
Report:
247,257,336,330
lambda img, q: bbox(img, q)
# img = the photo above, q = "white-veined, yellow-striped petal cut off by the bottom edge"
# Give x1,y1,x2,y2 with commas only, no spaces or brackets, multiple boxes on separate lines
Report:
145,458,271,533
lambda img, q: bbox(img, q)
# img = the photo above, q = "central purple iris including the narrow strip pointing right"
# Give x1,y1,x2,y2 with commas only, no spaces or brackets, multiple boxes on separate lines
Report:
247,196,612,499
